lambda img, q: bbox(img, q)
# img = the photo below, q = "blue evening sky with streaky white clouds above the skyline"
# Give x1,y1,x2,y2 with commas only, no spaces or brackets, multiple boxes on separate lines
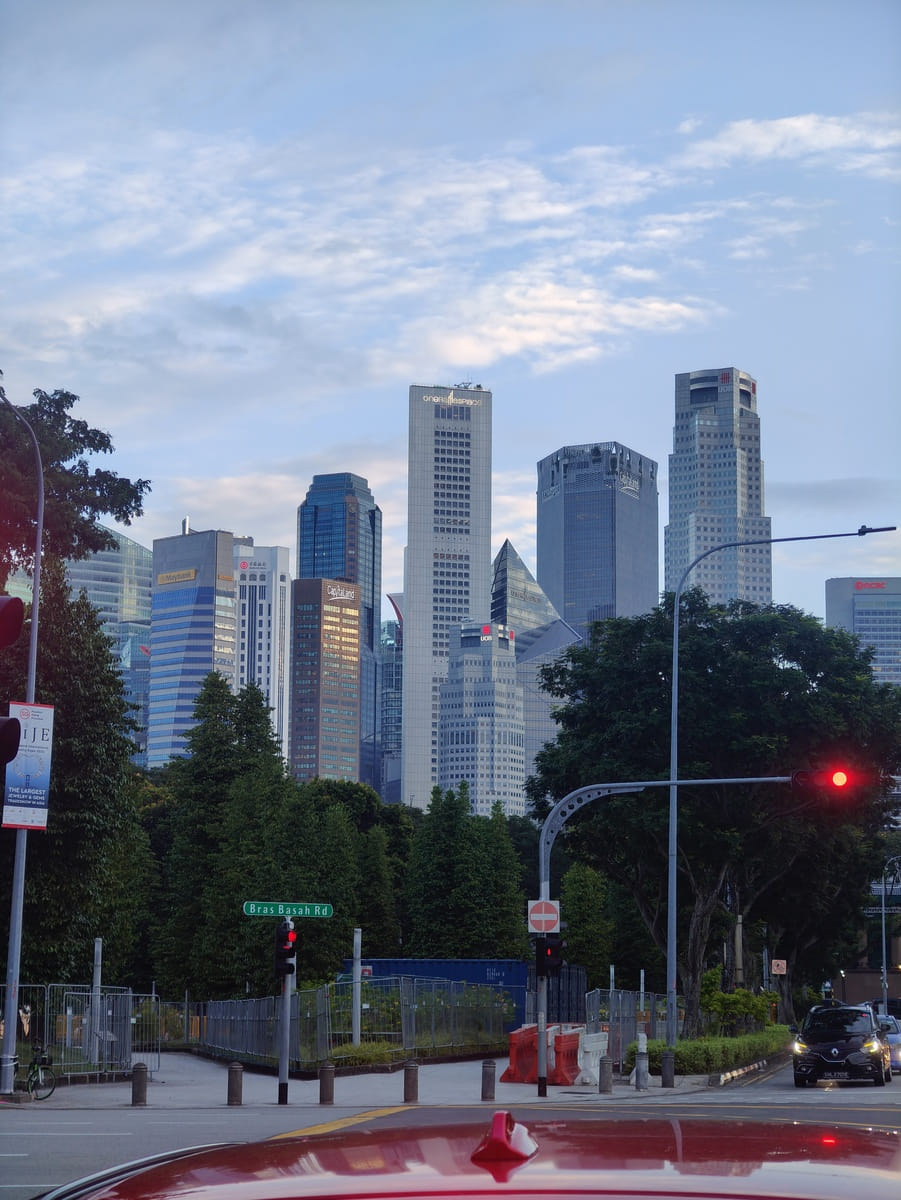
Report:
0,0,901,617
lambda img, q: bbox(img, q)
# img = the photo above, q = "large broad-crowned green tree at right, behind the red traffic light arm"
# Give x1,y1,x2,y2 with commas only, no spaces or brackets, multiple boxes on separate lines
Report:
528,589,901,1031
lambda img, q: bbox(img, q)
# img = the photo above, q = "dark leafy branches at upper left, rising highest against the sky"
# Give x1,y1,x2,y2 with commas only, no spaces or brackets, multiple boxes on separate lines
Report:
0,388,150,589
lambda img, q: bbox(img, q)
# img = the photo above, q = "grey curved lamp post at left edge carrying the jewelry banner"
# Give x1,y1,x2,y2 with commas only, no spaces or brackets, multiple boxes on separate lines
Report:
0,388,44,1096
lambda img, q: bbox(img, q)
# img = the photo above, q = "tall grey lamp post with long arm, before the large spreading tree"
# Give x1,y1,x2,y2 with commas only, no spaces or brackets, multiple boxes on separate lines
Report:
661,526,896,1087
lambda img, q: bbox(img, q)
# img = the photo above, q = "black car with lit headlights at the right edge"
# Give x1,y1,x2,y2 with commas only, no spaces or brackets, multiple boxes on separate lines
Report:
791,1004,891,1087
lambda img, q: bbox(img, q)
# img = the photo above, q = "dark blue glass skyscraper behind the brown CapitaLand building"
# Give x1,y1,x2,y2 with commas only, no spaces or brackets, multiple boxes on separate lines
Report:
298,472,382,788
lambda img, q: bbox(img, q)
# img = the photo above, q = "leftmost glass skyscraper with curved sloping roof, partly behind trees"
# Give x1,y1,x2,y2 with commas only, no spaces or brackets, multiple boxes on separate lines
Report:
66,529,154,767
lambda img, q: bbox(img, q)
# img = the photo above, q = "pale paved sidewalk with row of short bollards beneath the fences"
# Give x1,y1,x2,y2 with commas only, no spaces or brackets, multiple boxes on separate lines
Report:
17,1054,708,1114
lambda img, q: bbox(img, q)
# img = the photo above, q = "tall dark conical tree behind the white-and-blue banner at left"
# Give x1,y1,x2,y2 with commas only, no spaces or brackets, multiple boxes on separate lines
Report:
0,557,142,982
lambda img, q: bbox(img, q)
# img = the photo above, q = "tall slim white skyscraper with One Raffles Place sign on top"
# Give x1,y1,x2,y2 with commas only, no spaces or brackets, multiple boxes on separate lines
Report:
401,384,492,809
